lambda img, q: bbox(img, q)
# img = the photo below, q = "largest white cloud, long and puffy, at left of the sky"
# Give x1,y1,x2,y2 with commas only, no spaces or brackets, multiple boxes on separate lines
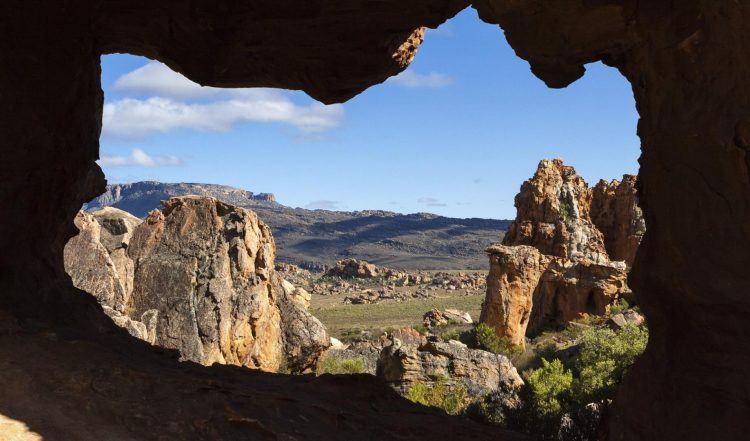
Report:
102,61,344,138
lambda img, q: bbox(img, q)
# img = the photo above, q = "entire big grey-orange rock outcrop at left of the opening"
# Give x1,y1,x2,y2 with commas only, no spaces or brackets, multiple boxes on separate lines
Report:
66,197,330,371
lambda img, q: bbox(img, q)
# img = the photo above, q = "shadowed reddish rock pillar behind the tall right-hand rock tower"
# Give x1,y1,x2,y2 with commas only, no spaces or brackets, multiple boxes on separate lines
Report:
591,175,646,266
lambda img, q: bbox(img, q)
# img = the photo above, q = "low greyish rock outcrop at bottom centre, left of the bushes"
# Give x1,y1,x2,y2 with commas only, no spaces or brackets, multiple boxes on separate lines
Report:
377,339,523,397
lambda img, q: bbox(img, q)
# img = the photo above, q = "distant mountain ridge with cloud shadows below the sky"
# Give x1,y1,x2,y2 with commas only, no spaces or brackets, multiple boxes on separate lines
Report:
83,181,511,269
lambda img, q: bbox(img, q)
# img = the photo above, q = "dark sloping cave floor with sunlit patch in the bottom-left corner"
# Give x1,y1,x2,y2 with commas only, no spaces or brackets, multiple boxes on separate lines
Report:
0,316,526,441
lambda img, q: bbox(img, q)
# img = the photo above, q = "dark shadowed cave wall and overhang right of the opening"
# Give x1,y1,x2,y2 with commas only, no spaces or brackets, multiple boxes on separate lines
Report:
472,0,750,440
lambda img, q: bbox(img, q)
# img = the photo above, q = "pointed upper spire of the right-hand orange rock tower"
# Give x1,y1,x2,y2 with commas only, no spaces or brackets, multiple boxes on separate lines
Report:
503,159,607,262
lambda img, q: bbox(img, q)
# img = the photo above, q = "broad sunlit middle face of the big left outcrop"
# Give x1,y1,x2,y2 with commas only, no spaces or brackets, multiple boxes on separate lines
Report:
128,197,284,371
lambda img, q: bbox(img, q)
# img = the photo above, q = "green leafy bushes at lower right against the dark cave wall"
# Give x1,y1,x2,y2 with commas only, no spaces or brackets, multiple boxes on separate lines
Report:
470,325,648,441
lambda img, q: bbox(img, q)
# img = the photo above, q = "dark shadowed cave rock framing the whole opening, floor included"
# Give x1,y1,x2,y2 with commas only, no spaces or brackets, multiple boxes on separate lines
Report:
0,0,750,439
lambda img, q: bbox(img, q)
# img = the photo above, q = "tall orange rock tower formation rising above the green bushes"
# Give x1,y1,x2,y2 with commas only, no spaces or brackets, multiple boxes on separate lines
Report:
480,159,642,346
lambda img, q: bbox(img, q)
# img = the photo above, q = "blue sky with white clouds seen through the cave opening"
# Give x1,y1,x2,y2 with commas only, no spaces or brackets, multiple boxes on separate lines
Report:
100,9,640,218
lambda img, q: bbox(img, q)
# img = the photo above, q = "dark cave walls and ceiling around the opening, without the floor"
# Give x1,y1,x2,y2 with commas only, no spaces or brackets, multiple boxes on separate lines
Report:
0,0,750,440
